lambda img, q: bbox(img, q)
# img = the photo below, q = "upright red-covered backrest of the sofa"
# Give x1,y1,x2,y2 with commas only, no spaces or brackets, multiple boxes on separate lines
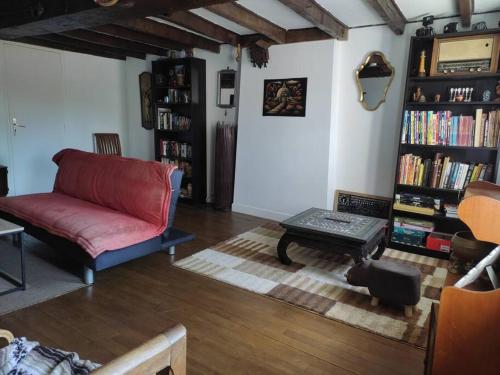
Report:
52,149,176,228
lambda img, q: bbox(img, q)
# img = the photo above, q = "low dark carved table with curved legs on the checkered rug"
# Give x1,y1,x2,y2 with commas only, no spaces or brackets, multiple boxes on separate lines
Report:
278,208,387,265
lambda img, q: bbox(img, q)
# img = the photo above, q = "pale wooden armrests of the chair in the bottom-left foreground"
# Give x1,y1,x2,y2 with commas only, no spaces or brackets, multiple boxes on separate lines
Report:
0,324,186,375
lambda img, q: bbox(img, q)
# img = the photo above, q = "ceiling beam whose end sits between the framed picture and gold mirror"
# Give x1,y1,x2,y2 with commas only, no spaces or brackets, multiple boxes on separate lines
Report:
279,0,348,40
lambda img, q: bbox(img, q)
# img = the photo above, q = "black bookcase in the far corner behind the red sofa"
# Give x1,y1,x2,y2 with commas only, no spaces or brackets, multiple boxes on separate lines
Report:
152,57,207,205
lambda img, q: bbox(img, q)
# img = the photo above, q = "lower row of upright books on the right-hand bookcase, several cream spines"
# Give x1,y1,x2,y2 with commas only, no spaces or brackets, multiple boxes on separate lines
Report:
398,153,493,190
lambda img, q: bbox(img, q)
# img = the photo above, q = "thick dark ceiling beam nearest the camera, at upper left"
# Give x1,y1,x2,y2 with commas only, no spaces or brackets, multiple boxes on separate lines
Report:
0,0,235,39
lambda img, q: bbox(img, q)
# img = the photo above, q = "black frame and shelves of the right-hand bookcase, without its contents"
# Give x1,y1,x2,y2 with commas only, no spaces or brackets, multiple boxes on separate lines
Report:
389,30,500,259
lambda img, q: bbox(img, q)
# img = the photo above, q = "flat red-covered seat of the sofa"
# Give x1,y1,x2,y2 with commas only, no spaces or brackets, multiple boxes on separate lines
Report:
0,193,162,258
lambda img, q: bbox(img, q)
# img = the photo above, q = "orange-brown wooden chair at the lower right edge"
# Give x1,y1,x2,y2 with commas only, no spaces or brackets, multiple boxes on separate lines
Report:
426,183,500,375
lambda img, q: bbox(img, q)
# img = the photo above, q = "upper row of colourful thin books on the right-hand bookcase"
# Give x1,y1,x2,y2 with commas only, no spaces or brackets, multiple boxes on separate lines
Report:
401,108,500,147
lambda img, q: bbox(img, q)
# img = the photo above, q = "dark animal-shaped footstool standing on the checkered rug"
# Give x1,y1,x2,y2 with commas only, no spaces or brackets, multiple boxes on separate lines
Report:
347,260,421,317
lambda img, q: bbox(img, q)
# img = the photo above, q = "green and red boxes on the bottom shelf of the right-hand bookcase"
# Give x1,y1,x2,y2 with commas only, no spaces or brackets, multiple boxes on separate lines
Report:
392,216,452,252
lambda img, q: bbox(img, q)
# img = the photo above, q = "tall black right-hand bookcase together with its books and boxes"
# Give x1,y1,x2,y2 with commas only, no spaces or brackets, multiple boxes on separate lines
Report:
389,30,500,258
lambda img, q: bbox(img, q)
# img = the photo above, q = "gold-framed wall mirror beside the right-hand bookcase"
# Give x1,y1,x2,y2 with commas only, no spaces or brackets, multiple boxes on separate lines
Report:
356,51,394,111
